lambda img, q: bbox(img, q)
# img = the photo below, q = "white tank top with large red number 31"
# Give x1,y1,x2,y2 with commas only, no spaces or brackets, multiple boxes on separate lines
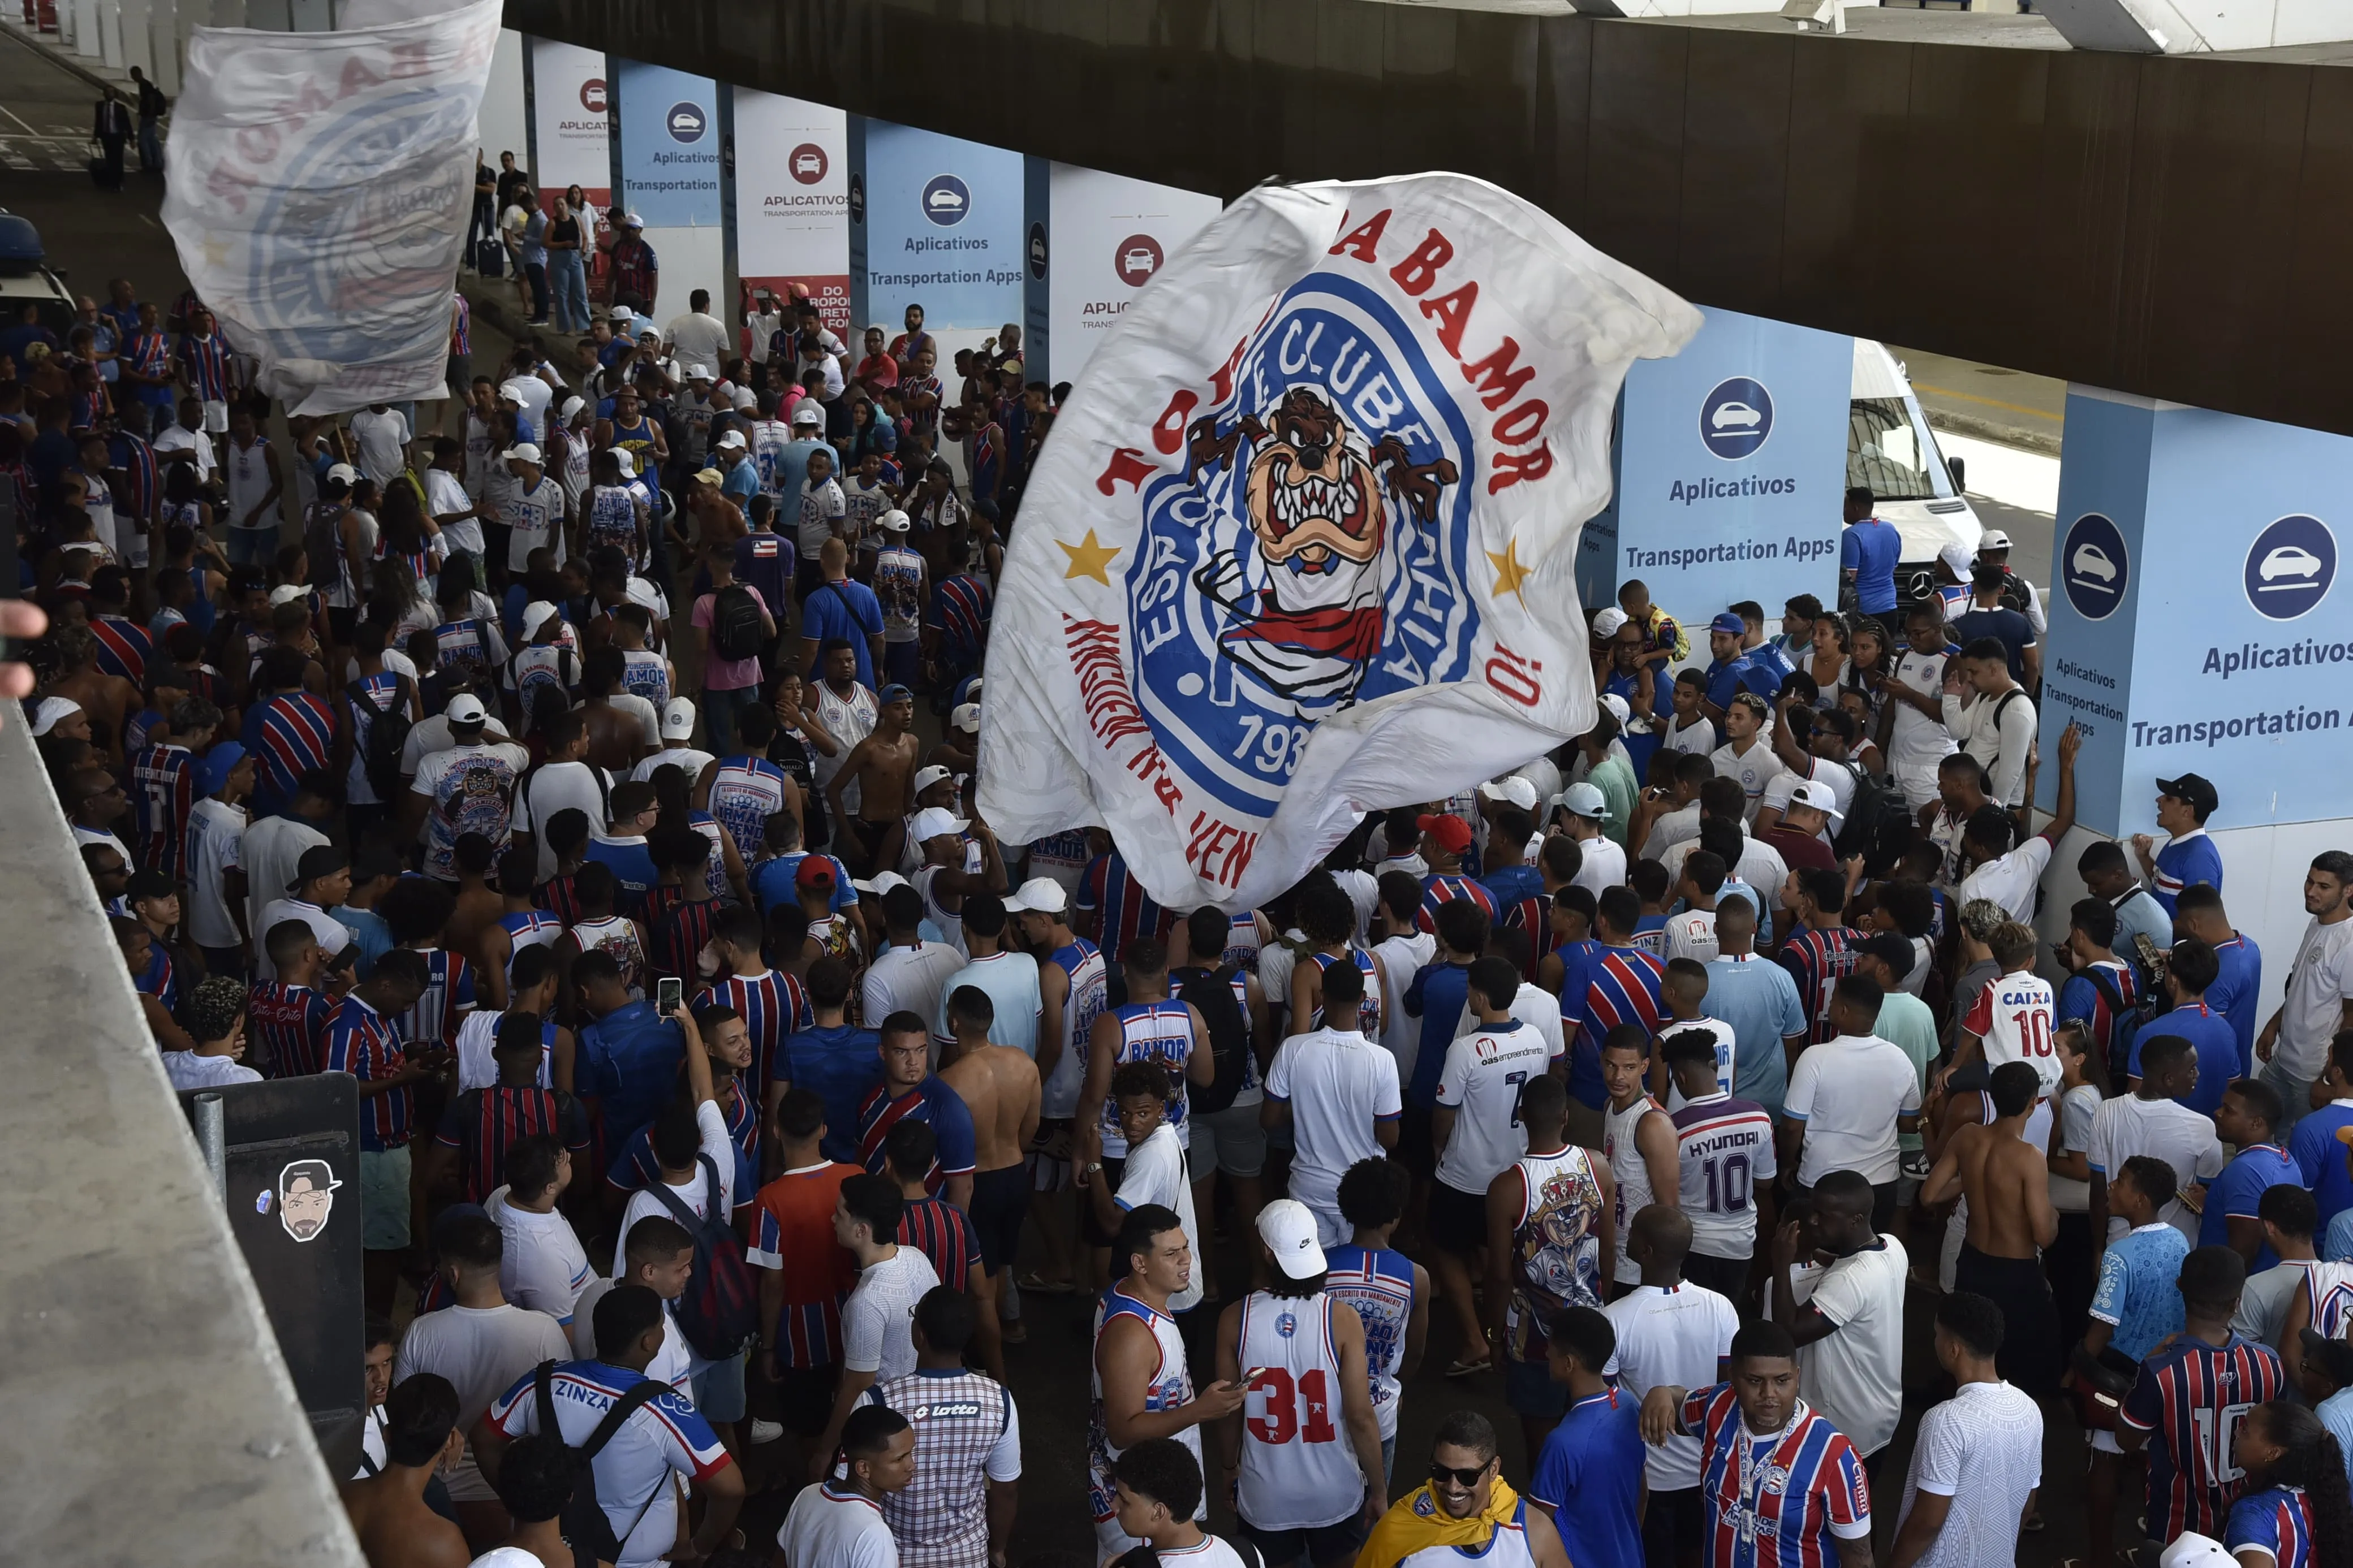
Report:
1235,1290,1365,1530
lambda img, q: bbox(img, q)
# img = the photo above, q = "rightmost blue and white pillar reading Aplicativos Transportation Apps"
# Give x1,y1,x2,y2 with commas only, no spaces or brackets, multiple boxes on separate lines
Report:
2035,386,2353,1009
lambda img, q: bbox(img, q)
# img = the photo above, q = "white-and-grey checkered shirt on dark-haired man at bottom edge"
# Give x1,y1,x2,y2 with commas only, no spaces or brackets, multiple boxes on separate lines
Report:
856,1366,1021,1568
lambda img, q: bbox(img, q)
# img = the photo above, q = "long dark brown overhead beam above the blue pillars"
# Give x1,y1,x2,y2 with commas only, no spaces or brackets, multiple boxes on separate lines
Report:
506,0,2353,433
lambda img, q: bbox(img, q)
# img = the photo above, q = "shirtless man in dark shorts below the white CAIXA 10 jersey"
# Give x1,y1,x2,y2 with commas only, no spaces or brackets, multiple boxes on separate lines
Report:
1920,1062,2059,1399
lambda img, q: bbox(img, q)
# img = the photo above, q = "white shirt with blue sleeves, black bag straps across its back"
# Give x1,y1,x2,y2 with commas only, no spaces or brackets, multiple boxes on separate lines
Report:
485,1361,732,1568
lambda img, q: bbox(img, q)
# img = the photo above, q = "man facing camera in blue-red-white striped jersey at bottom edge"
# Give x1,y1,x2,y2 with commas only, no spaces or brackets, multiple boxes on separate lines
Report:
1643,1324,1871,1568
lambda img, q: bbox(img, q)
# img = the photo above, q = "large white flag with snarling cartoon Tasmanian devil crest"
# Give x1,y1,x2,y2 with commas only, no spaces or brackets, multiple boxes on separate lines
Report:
981,174,1699,908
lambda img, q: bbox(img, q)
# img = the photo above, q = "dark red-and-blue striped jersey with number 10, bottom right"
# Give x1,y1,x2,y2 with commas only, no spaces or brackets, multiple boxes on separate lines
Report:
2118,1333,2287,1540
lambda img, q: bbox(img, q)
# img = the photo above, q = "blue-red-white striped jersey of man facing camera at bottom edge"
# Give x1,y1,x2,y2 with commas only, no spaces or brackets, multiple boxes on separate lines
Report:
1682,1383,1871,1568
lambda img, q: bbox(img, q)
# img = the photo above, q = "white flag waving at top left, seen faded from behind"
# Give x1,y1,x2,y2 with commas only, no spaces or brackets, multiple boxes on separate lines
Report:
162,0,501,414
